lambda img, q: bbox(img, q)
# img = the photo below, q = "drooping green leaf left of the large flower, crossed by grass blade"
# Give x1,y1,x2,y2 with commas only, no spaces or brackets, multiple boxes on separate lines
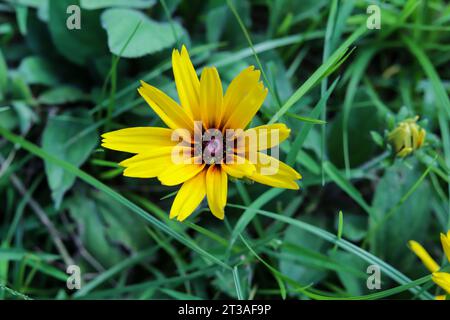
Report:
42,111,98,208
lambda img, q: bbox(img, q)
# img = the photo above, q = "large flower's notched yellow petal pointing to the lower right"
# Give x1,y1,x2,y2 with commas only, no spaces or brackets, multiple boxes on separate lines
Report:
250,153,302,190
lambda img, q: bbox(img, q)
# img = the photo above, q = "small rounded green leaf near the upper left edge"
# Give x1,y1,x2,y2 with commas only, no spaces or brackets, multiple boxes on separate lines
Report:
18,56,58,86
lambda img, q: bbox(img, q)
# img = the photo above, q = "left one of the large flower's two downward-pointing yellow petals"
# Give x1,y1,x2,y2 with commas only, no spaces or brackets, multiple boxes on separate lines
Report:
170,171,206,221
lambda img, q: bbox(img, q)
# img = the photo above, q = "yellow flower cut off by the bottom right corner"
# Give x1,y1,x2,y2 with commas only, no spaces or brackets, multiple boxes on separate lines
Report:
409,230,450,300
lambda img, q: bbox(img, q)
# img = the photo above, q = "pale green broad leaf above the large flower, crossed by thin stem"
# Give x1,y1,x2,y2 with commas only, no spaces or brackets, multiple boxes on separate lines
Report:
101,9,184,58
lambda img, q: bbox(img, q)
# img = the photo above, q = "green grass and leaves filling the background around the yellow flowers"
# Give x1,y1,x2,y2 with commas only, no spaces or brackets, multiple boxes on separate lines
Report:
0,0,450,299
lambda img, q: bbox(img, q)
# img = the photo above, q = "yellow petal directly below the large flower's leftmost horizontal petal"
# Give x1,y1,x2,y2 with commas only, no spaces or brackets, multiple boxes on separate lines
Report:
119,147,191,178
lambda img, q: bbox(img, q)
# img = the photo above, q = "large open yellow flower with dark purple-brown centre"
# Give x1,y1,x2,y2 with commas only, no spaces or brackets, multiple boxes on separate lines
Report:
102,46,301,221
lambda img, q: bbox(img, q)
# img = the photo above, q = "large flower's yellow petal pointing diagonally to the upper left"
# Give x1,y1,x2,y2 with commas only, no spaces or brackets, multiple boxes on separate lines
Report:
138,81,194,131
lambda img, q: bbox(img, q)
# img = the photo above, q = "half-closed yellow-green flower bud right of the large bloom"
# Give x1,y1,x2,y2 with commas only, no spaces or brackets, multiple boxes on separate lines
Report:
388,116,426,158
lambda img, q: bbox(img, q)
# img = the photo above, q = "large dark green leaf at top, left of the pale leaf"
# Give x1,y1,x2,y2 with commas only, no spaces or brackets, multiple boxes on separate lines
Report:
48,0,107,65
